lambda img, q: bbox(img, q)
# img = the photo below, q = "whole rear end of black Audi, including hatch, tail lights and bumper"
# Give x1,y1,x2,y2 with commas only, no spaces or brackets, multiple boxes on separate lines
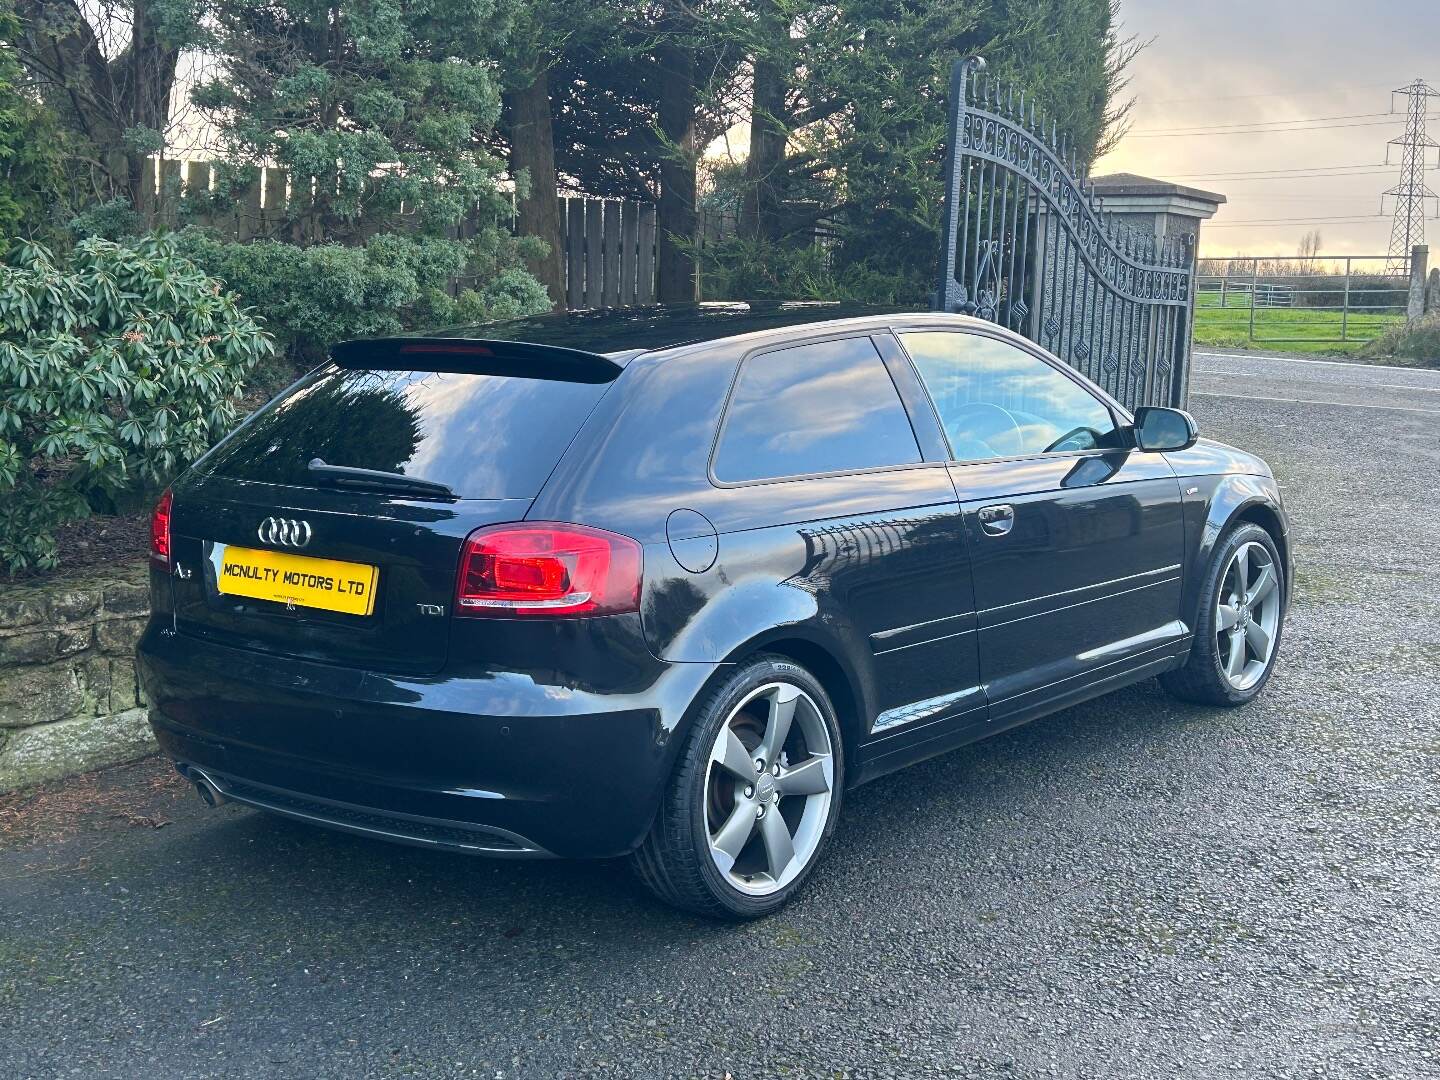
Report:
141,341,699,855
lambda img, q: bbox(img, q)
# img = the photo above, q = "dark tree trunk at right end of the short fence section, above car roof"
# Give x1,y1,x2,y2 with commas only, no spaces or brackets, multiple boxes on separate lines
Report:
655,27,700,304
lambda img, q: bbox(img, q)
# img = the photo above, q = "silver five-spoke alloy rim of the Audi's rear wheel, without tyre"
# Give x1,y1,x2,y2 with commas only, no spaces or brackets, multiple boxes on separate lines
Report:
703,683,835,896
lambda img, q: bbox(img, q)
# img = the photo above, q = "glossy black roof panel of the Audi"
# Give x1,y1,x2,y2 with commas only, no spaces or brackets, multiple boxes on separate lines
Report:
426,301,917,363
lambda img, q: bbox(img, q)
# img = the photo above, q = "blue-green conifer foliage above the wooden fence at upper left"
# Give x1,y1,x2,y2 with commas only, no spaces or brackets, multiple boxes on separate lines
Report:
192,0,517,249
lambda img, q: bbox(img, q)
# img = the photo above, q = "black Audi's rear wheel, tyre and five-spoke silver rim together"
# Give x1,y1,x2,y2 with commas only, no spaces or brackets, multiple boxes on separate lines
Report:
632,657,844,919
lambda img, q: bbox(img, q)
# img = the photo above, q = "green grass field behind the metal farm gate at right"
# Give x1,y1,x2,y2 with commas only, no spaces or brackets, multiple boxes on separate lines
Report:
1195,289,1405,356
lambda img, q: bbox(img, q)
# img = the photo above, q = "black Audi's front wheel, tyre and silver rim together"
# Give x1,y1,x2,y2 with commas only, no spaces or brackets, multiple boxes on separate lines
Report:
1161,523,1286,706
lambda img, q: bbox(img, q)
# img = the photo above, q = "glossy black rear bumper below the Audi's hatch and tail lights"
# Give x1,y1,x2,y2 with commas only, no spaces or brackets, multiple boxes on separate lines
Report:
140,619,714,858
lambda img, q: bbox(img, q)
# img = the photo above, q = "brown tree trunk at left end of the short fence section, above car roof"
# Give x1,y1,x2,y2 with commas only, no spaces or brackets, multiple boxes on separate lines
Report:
505,71,564,307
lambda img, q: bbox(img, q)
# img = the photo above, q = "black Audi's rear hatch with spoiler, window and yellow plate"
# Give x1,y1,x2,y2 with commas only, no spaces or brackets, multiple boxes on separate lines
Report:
170,338,621,674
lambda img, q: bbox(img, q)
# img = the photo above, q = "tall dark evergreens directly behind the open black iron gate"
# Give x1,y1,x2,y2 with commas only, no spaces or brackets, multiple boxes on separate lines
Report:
710,0,1136,302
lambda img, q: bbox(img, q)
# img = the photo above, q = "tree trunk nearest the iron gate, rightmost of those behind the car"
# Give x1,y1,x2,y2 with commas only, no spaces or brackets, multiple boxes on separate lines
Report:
740,0,791,240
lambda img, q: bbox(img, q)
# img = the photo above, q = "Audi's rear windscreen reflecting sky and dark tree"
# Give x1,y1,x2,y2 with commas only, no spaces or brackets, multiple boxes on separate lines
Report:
203,366,609,498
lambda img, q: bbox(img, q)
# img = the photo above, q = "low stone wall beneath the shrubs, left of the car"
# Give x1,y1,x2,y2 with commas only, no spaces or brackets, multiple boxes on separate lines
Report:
0,566,156,792
